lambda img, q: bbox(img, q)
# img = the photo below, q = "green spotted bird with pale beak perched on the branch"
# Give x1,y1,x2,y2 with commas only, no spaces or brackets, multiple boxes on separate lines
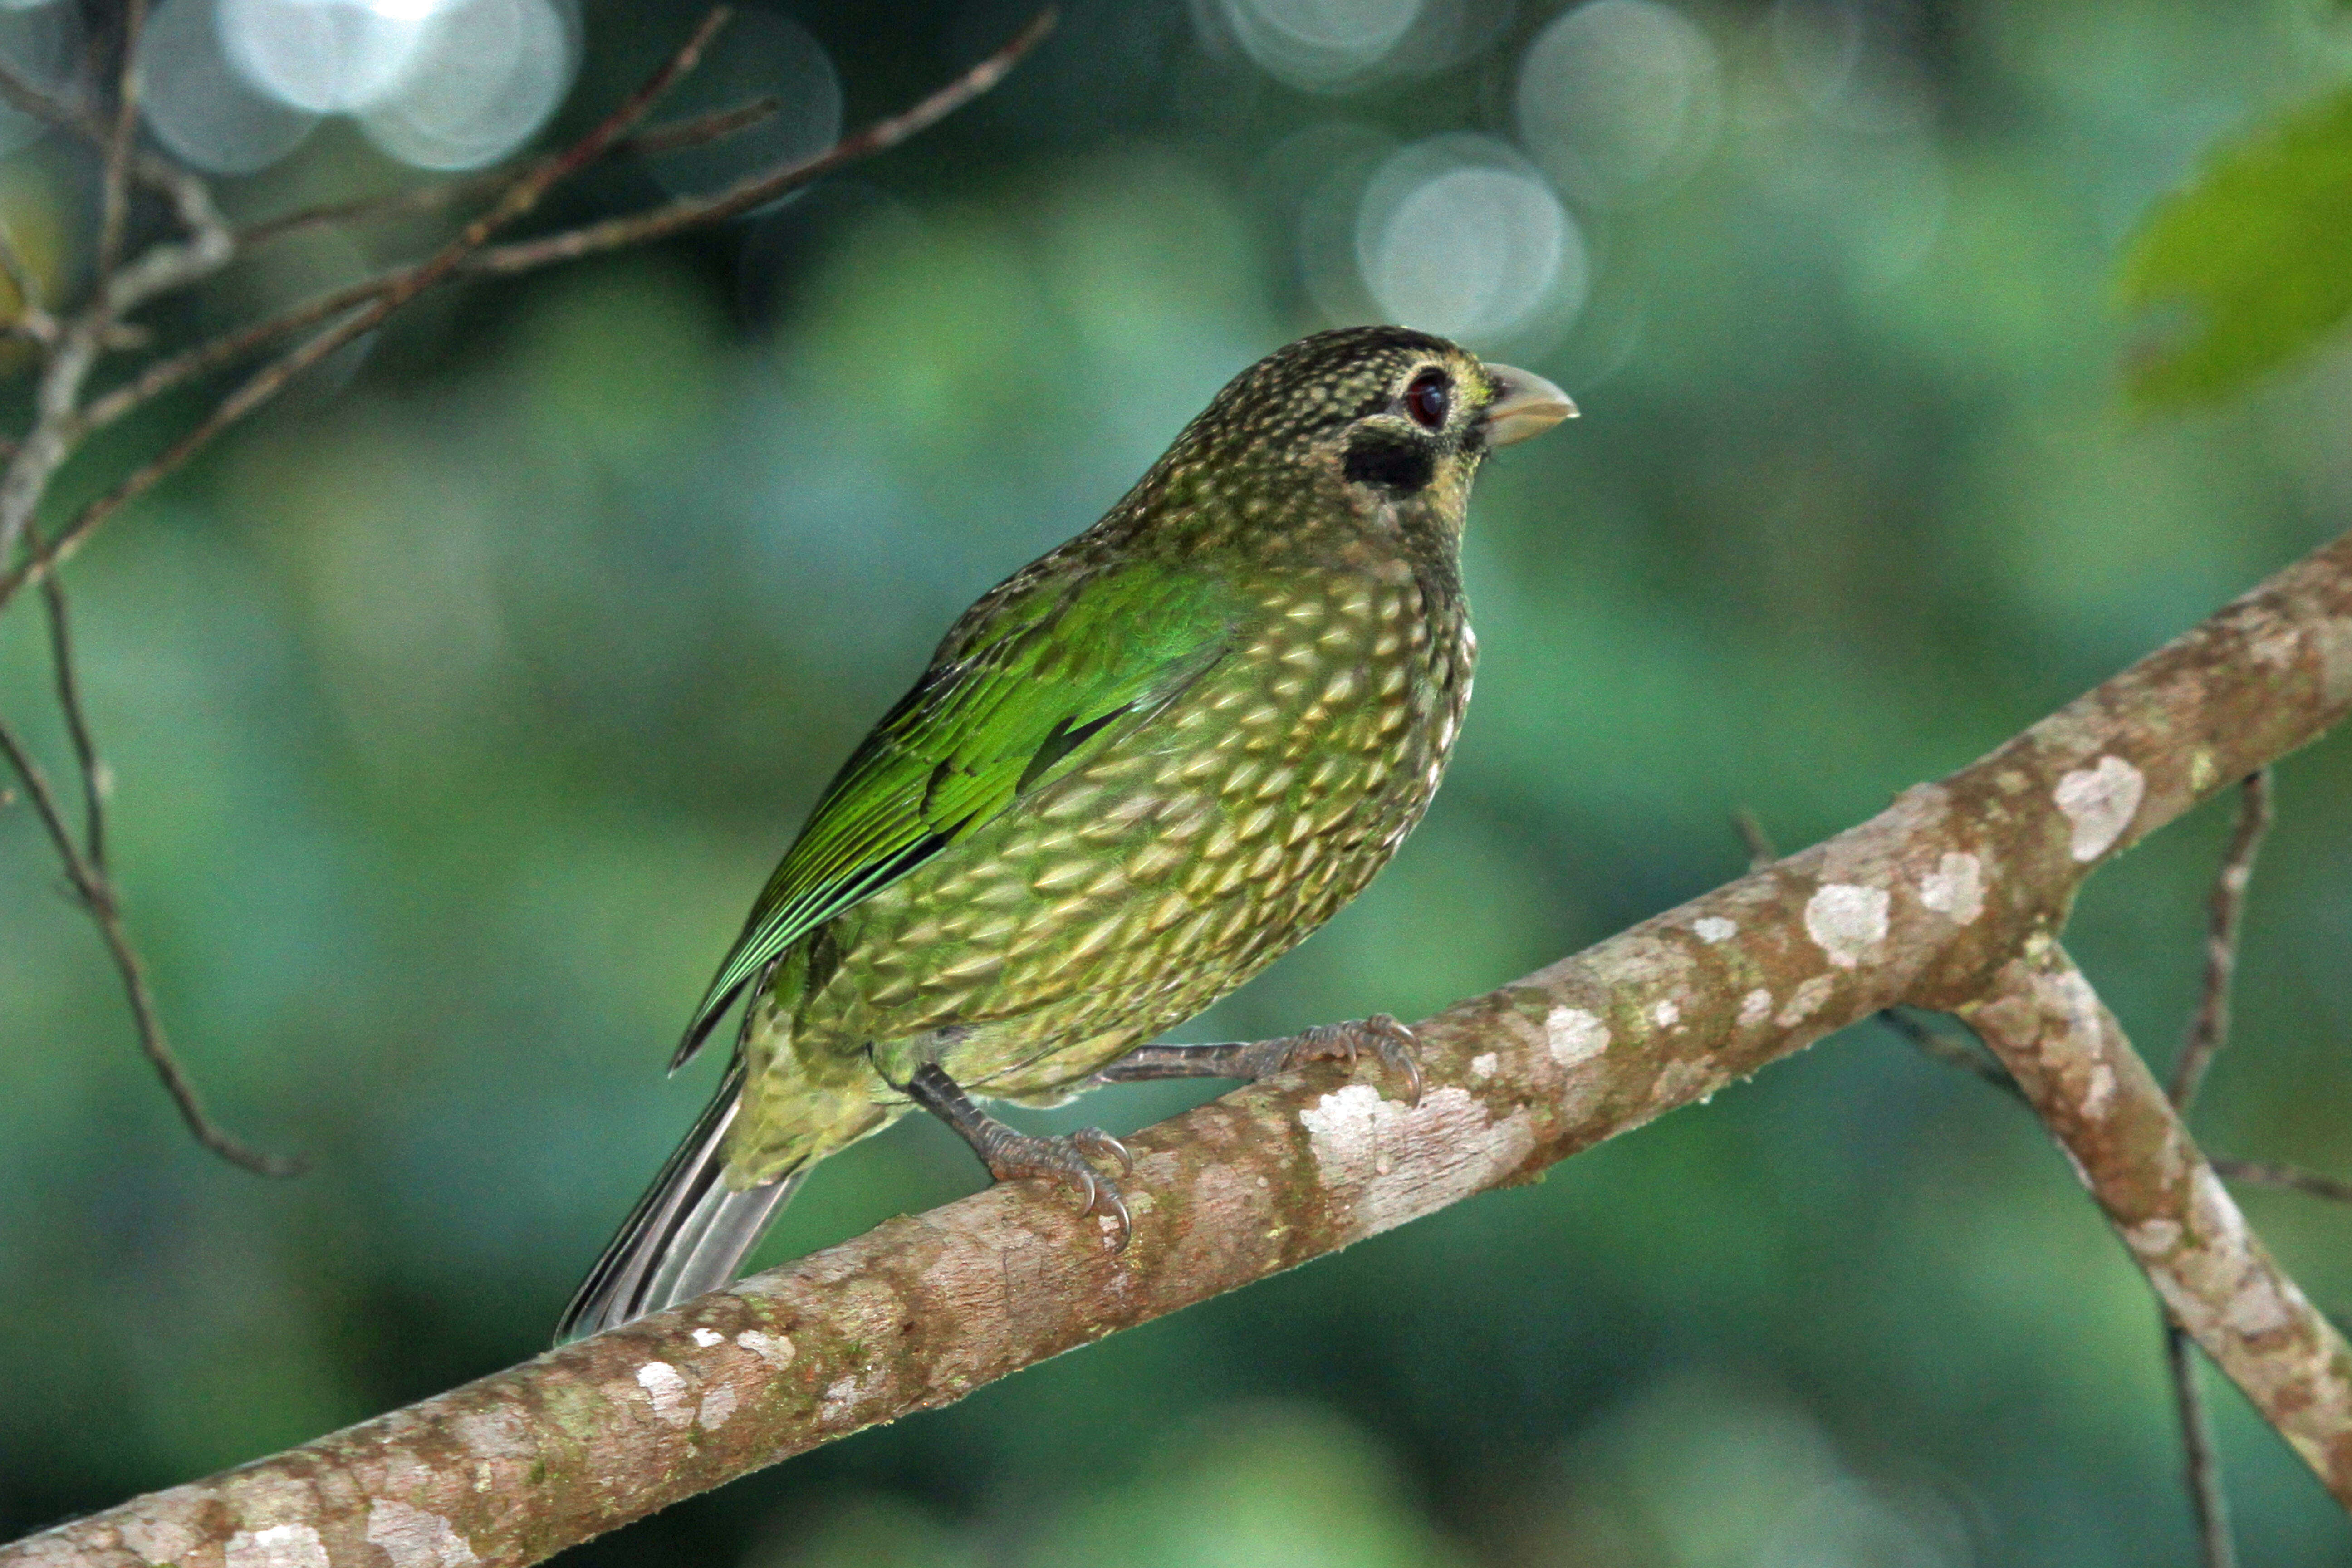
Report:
558,327,1576,1343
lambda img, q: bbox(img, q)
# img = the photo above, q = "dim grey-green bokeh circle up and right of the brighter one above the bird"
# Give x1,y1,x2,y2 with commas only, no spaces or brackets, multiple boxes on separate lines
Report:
1517,0,1722,207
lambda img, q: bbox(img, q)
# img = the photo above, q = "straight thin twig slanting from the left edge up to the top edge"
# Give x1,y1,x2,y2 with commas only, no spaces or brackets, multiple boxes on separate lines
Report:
0,5,731,609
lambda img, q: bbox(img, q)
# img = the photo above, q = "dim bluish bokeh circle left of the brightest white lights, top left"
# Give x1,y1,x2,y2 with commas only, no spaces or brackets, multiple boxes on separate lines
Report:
139,0,318,174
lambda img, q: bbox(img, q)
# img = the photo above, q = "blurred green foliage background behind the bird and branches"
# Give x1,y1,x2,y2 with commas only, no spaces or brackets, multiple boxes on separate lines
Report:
0,0,2352,1568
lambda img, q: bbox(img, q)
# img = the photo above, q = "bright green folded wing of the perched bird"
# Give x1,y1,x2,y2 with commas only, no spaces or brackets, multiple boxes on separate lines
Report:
670,571,1235,1067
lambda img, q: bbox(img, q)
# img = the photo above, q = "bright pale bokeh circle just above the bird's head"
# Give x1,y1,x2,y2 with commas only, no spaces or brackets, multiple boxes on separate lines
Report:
1355,134,1590,343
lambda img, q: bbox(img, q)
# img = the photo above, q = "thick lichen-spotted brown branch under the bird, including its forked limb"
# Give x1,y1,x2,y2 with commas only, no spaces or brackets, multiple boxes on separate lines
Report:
14,536,2352,1568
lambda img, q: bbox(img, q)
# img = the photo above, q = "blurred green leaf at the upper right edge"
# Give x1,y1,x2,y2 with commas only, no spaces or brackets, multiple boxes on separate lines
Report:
2119,89,2352,407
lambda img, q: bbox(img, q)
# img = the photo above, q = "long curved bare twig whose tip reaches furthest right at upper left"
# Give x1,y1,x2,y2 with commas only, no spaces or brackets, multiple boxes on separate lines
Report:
76,7,1056,444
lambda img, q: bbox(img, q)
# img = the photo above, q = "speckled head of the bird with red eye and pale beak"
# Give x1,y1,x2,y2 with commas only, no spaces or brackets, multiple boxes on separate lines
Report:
1160,327,1576,552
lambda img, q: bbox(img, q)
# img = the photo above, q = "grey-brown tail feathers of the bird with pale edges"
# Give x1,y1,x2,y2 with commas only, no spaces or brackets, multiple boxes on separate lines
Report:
555,1063,804,1345
